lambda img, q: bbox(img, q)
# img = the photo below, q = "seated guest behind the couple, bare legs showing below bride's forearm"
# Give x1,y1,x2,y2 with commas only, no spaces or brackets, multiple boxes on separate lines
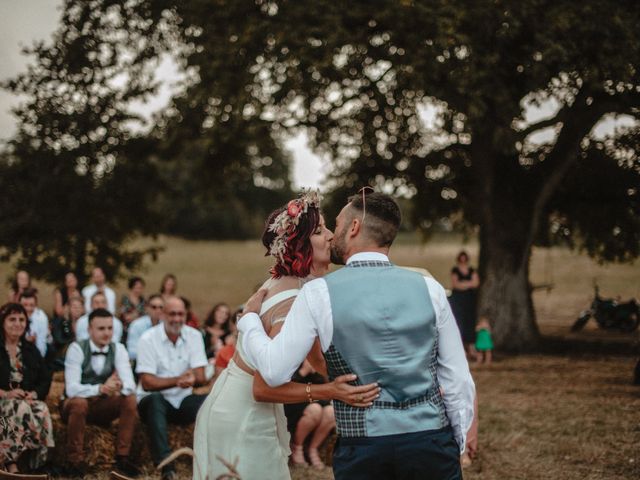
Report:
284,360,336,470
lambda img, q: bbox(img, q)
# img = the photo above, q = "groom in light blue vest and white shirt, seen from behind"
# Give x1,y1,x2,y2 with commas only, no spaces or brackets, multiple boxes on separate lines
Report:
238,193,475,480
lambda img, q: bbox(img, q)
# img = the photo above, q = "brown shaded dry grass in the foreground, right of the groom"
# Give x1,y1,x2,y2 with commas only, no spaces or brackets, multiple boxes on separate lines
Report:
46,355,640,480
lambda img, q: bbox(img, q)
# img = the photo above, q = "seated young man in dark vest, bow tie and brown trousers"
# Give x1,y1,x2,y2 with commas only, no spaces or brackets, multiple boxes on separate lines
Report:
62,308,140,478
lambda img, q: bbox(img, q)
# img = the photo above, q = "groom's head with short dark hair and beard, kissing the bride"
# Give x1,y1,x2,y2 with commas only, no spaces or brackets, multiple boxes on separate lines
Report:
331,192,402,265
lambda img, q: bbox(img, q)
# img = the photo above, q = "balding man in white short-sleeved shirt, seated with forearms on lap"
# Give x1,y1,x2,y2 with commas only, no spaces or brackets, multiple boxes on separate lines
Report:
136,297,207,480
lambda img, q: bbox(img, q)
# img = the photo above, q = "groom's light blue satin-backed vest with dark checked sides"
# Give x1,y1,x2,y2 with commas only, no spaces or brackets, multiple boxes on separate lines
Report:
325,261,449,437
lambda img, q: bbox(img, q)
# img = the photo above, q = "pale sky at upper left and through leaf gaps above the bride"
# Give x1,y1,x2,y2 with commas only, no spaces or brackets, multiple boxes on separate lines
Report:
0,0,328,188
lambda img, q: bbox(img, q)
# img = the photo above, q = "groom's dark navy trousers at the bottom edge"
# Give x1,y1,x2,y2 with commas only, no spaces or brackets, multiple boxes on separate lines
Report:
333,427,462,480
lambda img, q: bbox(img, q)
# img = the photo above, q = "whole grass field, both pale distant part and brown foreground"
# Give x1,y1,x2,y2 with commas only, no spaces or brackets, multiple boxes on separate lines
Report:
5,238,640,480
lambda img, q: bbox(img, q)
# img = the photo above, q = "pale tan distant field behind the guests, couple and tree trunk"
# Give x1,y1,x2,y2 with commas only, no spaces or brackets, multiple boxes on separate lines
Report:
13,233,640,338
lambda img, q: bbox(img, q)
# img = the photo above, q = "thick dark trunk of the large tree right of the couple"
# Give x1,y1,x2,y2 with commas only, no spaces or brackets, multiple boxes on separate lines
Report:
478,218,539,352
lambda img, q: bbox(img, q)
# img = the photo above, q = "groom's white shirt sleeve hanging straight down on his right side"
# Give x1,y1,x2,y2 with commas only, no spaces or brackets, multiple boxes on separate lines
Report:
425,278,476,453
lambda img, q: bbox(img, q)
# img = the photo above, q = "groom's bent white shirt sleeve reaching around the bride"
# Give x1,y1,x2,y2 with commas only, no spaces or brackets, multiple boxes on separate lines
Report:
238,280,333,387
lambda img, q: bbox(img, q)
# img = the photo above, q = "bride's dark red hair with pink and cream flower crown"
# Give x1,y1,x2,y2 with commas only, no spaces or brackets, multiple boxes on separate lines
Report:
262,191,320,278
